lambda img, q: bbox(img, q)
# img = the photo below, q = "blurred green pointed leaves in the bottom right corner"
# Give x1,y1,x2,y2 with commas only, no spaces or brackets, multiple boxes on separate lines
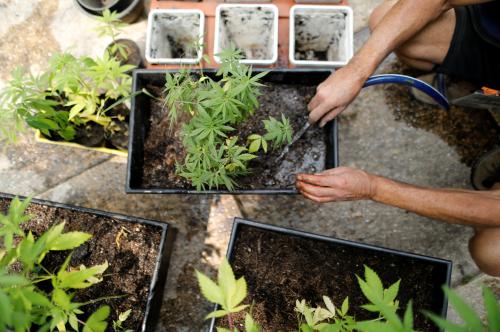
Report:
425,286,500,332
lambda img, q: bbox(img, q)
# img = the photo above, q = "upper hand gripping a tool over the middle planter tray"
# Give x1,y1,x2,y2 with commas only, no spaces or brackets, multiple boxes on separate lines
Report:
307,65,365,127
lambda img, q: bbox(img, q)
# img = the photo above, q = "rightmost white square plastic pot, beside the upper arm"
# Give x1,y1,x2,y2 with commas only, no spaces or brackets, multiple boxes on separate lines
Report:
289,5,354,67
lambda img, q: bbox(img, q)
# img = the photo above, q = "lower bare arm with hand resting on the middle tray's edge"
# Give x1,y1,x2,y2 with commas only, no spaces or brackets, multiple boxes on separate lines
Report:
297,167,500,227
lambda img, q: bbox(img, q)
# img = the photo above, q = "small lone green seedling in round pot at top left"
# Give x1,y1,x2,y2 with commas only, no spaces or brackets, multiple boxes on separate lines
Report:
95,9,128,60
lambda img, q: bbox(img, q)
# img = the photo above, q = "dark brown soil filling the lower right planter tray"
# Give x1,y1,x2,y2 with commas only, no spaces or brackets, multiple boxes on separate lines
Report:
216,225,444,332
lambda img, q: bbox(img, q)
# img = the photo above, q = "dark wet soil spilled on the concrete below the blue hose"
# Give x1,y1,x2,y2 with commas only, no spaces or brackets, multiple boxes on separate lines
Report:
383,62,500,166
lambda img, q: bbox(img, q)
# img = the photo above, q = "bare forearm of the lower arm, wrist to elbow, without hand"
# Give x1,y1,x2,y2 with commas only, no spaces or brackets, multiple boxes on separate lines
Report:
372,176,500,227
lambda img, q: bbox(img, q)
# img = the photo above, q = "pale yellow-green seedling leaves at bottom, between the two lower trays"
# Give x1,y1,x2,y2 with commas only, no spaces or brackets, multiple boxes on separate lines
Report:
196,258,261,332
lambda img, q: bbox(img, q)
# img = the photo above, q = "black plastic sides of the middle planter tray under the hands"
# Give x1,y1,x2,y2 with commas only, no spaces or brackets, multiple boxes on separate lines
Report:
125,69,339,194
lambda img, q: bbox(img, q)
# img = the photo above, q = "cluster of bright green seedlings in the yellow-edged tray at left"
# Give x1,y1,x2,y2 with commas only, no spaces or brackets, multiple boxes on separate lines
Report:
0,53,134,142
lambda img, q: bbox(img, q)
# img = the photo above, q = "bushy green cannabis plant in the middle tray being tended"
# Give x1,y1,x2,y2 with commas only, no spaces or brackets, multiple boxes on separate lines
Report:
164,48,292,190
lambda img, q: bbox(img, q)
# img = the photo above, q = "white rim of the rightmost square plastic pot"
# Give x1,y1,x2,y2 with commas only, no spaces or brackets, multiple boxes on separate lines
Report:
288,4,354,67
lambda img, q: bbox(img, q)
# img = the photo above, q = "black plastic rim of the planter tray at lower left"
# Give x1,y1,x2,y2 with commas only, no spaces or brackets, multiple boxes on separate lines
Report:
0,193,175,332
